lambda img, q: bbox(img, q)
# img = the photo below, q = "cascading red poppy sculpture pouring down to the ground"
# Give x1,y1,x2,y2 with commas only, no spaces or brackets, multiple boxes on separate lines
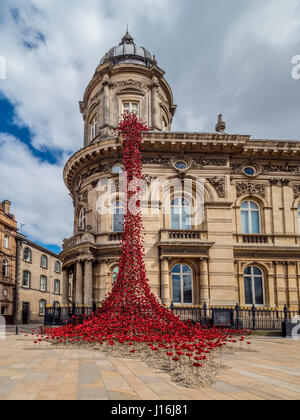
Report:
44,113,245,367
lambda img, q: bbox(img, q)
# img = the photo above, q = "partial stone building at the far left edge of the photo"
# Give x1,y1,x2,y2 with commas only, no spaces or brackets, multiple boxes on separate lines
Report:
0,200,17,323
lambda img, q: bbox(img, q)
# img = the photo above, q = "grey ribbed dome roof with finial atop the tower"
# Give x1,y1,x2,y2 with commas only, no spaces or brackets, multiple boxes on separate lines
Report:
100,31,153,67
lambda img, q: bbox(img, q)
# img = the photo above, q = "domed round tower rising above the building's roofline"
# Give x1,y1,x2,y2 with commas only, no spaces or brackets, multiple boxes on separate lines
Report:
80,32,176,146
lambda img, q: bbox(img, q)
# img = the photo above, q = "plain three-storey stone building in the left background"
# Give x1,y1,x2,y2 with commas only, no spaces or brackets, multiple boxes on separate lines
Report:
16,234,63,324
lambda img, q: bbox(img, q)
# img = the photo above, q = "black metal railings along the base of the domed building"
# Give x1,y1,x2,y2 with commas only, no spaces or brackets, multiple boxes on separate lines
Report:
44,304,300,332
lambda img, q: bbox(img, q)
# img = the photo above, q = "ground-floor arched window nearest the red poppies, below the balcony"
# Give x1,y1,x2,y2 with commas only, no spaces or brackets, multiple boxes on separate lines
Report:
172,264,193,303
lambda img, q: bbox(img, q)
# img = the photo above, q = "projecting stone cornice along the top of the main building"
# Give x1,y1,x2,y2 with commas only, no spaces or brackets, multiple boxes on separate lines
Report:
64,131,300,190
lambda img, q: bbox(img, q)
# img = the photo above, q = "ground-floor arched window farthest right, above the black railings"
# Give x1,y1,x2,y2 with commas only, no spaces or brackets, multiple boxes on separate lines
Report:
244,266,265,305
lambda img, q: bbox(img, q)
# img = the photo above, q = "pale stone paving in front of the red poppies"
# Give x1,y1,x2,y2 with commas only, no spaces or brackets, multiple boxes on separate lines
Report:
0,335,300,400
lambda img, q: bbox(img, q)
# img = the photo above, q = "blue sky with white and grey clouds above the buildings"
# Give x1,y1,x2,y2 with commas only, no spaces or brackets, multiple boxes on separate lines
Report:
0,0,300,252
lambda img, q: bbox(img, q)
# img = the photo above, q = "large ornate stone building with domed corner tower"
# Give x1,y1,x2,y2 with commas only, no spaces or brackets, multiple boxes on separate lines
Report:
61,33,300,308
